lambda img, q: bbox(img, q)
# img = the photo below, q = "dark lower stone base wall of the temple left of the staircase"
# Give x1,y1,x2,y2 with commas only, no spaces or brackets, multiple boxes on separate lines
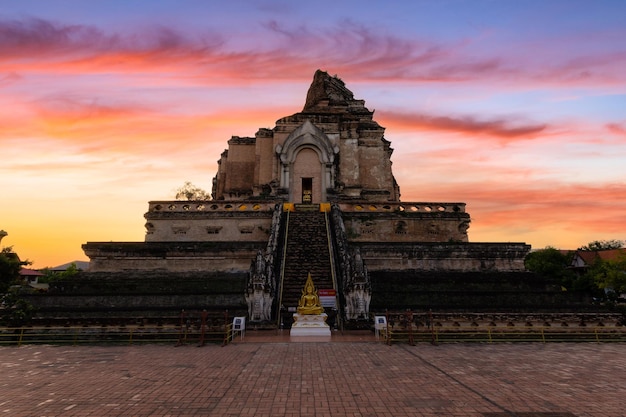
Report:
24,271,247,318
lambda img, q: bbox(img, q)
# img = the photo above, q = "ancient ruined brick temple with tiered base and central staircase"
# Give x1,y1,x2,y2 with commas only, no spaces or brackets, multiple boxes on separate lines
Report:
69,70,576,323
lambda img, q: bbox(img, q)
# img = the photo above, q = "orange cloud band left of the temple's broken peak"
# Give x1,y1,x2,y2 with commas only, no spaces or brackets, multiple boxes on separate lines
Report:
0,97,293,154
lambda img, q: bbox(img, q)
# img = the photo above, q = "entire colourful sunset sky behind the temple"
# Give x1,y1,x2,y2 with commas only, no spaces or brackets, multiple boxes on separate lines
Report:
0,0,626,268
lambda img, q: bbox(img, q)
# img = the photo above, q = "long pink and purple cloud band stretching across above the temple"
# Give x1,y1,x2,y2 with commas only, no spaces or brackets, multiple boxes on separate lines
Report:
0,19,626,85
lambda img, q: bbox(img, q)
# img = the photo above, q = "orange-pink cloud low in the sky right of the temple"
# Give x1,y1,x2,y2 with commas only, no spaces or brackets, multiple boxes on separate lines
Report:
400,179,626,247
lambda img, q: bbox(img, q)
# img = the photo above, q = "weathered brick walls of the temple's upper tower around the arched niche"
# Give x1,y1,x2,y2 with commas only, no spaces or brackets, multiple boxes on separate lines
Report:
215,72,399,202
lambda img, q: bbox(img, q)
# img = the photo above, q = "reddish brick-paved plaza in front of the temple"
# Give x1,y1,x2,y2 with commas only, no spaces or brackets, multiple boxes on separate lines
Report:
0,337,626,417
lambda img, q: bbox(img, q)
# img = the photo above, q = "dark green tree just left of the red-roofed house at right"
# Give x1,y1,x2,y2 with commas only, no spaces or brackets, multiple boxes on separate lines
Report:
524,246,576,289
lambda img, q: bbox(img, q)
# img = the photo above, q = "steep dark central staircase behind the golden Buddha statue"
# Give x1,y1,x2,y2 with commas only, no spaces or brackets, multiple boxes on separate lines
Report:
280,204,334,310
